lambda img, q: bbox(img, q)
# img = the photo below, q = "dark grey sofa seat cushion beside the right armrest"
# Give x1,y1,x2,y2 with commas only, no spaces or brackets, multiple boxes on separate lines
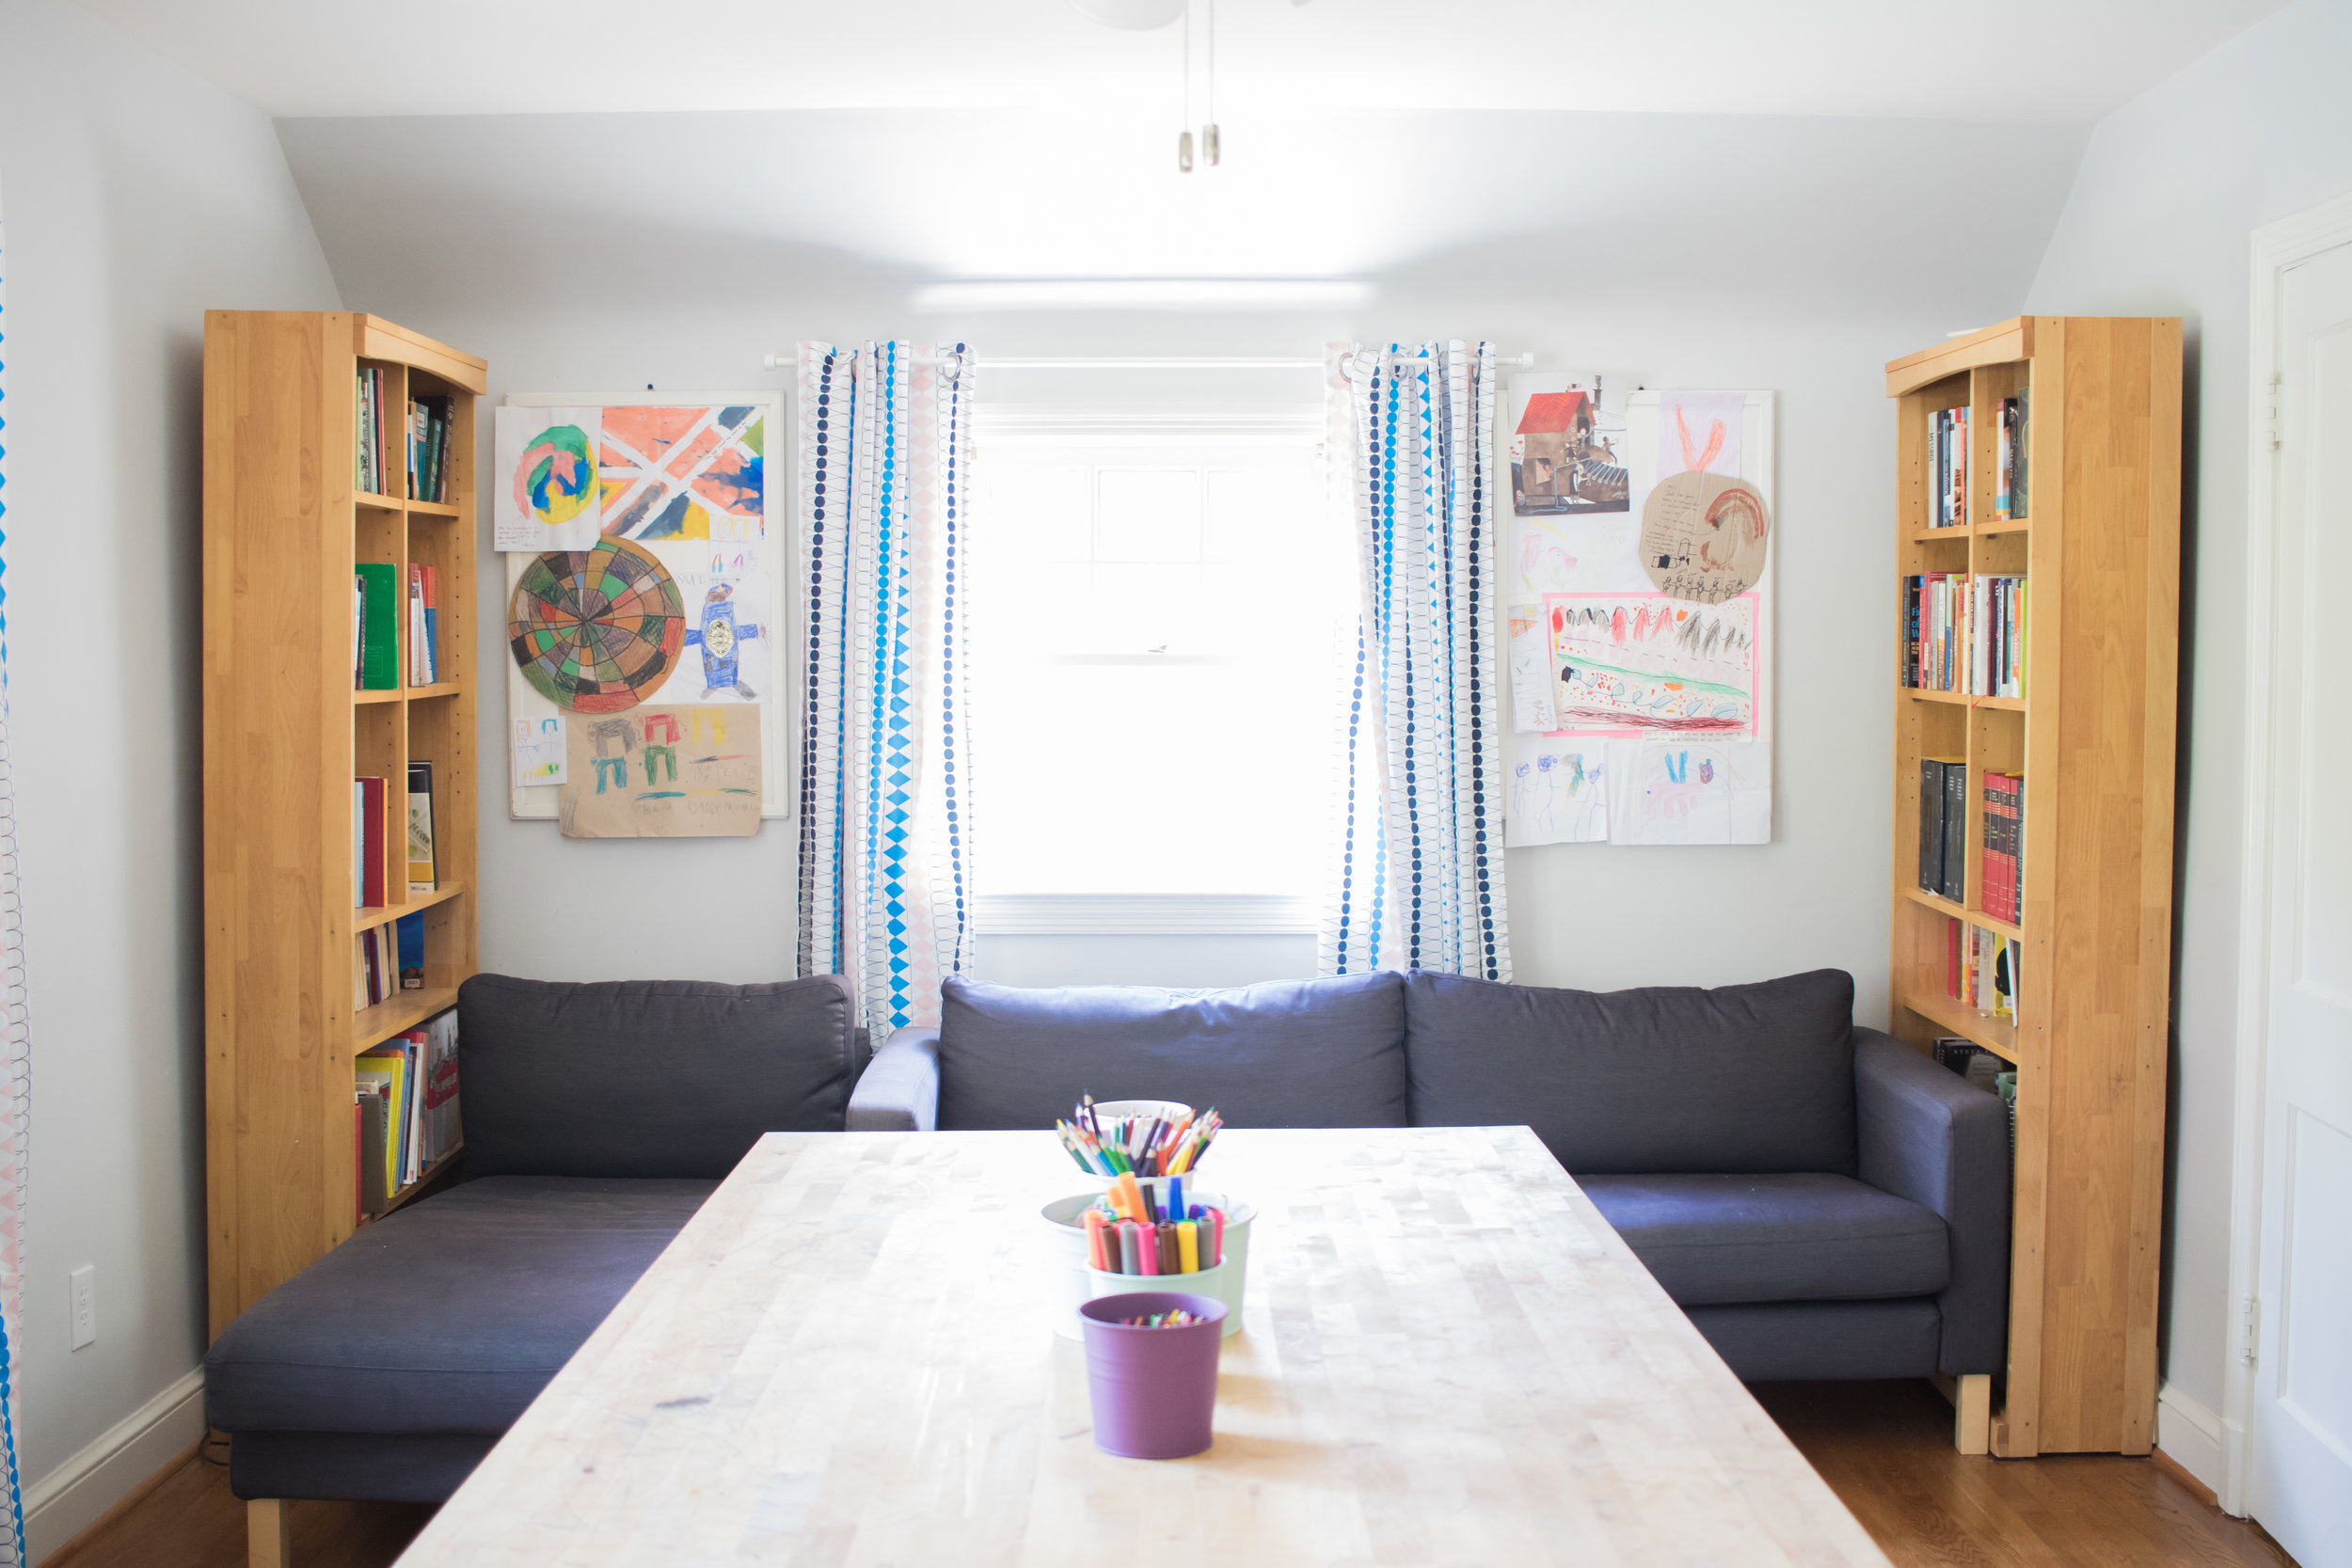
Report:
1579,1176,1952,1307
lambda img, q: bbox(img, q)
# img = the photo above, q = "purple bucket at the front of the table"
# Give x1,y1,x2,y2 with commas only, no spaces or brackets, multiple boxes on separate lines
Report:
1077,1291,1226,1460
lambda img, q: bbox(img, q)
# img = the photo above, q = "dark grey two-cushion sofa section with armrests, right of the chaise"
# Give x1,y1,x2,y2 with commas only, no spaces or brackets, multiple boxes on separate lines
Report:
850,969,2009,1380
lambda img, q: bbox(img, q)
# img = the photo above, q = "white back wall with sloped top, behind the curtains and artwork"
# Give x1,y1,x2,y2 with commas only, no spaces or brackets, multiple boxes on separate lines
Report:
280,113,2084,1022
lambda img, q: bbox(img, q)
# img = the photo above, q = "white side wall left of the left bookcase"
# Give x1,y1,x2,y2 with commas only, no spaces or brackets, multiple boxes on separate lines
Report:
0,0,339,1552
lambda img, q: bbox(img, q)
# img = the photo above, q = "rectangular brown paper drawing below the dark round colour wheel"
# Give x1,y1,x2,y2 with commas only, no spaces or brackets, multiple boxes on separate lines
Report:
555,703,760,839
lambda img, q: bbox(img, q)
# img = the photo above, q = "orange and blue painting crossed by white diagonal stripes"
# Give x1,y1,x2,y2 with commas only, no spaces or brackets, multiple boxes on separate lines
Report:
597,404,767,541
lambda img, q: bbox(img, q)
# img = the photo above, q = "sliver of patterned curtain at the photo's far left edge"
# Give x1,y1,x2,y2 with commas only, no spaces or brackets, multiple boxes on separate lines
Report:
0,186,33,1568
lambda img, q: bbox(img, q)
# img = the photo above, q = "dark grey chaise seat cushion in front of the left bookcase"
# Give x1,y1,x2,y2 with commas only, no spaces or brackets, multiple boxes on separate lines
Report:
205,1176,718,1434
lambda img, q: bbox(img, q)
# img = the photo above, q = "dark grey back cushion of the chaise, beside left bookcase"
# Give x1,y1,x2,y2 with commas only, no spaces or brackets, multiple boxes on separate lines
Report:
456,975,856,1178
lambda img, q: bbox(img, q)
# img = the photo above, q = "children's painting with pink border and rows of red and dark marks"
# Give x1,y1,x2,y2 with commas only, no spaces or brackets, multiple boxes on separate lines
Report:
1543,593,1757,736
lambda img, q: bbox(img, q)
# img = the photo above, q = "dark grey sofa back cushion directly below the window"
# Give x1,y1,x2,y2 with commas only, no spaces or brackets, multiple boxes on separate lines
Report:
939,974,1406,1131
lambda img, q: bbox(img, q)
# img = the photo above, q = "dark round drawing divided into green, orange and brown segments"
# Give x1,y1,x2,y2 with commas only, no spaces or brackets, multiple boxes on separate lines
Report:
506,538,687,712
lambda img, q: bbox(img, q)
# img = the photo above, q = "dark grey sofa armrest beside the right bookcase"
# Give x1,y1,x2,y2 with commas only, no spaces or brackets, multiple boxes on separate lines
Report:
1853,1030,2011,1378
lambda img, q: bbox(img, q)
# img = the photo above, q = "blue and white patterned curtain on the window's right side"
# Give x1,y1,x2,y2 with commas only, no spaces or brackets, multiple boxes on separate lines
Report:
1320,341,1510,980
